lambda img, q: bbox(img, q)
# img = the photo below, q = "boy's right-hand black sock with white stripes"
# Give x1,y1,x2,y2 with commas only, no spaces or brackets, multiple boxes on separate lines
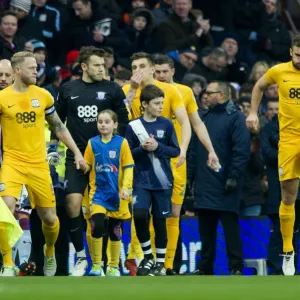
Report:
153,217,168,264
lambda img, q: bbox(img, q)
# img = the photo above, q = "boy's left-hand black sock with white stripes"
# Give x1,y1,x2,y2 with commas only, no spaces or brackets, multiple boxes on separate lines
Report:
134,213,153,259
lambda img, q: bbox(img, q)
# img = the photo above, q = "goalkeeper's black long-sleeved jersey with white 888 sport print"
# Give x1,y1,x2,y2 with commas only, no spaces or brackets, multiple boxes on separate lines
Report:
55,79,128,157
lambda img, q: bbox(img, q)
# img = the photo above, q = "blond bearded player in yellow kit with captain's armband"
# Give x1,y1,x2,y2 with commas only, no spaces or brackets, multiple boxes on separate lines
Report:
0,52,84,276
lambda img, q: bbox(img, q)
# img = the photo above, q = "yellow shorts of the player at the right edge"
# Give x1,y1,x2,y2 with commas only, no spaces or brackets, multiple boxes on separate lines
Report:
278,137,300,181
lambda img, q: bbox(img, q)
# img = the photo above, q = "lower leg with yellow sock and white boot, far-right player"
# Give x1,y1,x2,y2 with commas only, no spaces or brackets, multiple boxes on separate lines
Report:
279,178,299,276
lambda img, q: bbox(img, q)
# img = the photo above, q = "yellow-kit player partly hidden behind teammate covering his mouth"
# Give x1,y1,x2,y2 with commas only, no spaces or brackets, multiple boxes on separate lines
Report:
155,55,219,274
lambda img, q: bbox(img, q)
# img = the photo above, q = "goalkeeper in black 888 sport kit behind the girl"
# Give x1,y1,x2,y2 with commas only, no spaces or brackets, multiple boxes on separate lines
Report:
50,46,128,276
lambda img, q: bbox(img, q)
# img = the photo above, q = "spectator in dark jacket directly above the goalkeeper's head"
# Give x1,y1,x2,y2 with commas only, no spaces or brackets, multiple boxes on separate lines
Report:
65,0,126,52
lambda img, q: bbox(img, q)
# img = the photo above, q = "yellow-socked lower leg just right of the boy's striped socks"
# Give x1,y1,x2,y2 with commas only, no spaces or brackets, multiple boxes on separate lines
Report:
165,203,182,275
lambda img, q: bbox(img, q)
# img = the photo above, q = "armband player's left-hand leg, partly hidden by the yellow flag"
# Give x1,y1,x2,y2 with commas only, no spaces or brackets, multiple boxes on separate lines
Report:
0,196,19,276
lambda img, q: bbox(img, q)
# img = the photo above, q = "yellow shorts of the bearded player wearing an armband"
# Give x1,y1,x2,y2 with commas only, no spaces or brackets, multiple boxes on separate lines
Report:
0,161,56,208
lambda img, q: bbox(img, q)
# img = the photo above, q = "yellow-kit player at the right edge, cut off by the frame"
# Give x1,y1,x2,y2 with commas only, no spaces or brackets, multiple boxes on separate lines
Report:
246,36,300,276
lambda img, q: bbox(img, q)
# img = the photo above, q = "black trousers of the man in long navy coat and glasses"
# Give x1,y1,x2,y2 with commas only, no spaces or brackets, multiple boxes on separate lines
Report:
198,209,243,275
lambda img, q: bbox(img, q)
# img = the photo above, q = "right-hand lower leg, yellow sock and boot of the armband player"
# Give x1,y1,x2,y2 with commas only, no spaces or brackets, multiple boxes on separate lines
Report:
36,206,59,276
